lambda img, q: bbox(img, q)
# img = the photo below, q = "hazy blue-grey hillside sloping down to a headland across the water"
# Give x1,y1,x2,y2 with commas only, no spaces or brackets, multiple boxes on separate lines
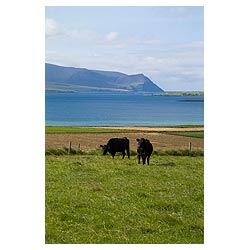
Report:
45,63,163,93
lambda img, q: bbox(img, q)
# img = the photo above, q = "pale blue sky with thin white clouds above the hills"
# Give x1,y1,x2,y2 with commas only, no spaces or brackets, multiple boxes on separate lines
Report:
45,6,204,91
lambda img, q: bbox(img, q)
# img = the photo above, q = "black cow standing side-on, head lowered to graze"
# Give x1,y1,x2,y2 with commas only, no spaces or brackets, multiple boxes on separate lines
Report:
100,137,130,159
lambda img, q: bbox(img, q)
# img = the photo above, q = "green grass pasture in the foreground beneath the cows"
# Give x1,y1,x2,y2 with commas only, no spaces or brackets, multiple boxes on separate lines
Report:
46,152,204,244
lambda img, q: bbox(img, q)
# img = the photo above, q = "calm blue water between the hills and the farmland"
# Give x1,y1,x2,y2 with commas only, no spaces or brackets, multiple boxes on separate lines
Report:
45,92,204,126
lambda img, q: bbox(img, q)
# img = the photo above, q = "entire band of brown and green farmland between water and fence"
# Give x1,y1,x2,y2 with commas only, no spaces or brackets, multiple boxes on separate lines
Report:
45,127,204,151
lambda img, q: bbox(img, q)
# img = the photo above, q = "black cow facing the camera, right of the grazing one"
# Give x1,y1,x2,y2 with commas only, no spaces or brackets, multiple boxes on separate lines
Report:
136,138,153,165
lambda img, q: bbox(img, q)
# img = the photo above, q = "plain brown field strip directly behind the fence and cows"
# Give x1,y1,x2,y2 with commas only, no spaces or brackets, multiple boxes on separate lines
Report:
45,131,204,150
